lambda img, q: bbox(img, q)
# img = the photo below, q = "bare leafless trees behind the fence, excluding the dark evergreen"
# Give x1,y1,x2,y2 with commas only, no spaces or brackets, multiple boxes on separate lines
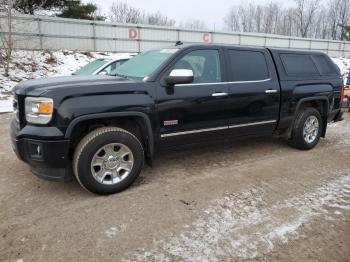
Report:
107,0,350,40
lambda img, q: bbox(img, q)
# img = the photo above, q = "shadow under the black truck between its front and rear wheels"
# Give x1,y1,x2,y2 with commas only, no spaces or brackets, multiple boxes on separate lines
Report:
133,138,290,187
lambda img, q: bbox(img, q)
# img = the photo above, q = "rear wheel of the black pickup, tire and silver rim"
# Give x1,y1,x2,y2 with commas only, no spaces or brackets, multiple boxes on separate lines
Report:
289,107,323,150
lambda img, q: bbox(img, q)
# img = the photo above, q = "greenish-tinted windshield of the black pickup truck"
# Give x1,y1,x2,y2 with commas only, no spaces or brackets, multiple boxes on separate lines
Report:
116,48,179,78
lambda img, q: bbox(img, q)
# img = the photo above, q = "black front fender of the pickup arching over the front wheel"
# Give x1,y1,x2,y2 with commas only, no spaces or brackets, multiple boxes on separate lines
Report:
55,93,156,162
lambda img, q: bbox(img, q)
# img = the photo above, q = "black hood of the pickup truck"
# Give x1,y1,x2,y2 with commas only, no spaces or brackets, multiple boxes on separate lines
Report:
13,75,133,96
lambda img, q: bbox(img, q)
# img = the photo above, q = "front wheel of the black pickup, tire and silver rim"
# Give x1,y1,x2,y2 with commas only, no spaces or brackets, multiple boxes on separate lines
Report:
73,127,144,195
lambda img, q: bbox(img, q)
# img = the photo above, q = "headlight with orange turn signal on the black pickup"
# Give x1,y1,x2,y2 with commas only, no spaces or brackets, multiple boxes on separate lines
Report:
25,97,53,125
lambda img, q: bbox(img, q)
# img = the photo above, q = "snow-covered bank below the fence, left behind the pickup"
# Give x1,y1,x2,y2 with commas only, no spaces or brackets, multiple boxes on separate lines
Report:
0,50,134,113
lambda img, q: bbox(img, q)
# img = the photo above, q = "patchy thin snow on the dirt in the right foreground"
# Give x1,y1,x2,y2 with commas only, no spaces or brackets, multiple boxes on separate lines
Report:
124,175,350,261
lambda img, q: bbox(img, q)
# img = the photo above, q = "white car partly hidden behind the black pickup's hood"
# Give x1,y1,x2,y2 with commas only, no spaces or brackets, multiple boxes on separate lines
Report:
73,54,135,76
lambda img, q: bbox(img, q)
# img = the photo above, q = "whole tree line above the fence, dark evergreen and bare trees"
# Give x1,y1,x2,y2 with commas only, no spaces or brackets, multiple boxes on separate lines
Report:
0,0,350,40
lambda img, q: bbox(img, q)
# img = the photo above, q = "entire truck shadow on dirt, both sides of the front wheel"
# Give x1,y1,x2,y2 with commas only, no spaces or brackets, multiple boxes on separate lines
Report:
31,138,295,196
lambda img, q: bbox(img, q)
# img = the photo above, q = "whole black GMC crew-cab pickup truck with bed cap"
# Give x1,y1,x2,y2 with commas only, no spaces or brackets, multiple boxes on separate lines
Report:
11,45,342,194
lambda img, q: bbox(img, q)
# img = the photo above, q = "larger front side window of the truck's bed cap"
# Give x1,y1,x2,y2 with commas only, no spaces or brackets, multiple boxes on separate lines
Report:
280,54,320,76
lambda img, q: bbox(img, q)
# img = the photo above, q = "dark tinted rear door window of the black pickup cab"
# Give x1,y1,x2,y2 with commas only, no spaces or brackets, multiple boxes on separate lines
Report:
228,49,269,81
